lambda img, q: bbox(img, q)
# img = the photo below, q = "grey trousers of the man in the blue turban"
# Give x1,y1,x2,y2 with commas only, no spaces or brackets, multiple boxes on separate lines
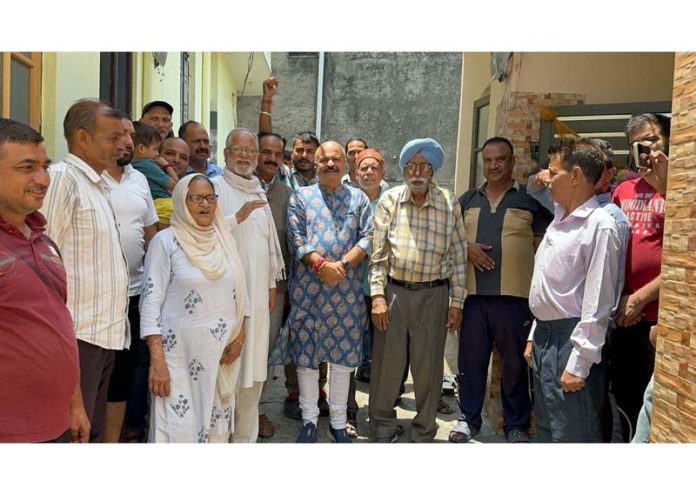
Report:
368,283,449,442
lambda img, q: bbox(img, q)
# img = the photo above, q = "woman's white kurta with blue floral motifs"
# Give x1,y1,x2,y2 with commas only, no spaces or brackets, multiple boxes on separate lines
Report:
140,229,245,442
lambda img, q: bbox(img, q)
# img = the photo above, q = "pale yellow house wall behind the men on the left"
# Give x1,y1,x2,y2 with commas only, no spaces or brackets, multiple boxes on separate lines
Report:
41,52,270,162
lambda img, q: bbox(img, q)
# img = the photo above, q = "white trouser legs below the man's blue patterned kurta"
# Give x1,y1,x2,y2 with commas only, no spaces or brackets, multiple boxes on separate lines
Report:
300,363,354,430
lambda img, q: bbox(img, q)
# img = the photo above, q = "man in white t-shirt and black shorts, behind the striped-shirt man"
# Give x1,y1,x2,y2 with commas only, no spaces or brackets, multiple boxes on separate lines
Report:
102,115,159,443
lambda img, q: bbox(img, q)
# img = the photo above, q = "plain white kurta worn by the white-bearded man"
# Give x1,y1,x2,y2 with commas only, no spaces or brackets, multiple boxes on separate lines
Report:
213,176,282,388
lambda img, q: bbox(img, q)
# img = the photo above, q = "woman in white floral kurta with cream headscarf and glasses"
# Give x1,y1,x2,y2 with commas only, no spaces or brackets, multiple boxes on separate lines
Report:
140,174,249,443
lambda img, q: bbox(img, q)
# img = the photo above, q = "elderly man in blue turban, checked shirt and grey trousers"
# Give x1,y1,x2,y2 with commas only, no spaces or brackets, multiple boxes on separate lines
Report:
369,138,466,443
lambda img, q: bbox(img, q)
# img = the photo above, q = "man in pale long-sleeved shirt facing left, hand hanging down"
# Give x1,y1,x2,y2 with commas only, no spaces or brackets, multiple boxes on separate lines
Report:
525,138,621,442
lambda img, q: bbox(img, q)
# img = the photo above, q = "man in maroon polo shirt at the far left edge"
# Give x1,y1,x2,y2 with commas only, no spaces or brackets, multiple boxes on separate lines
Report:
0,119,90,442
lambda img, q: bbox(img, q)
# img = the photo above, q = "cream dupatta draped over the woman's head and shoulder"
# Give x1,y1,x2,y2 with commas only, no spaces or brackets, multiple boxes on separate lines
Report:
169,174,247,402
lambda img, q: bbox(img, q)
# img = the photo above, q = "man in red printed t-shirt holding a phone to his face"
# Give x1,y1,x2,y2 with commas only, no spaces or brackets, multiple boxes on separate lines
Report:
608,113,670,441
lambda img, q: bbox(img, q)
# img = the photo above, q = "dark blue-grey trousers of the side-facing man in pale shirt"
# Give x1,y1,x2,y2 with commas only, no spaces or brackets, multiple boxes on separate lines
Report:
532,318,606,443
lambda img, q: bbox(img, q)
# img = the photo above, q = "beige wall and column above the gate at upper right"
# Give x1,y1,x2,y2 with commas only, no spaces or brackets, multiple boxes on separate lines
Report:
454,52,674,194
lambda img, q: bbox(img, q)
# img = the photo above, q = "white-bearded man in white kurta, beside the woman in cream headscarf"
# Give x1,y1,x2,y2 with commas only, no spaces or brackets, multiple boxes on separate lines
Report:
213,128,285,443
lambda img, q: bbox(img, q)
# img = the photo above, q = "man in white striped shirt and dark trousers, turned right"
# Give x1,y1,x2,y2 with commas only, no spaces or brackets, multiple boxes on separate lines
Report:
41,99,132,442
